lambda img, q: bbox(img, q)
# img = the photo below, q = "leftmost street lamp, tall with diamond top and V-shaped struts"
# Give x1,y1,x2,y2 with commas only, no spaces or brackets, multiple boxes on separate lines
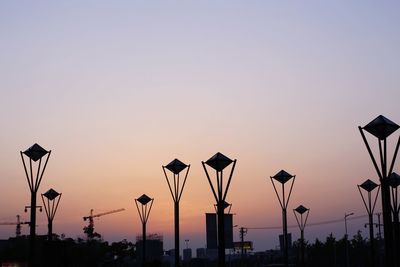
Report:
20,144,51,267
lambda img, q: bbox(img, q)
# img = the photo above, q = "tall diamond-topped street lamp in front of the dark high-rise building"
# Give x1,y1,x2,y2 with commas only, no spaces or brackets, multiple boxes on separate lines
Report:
201,152,236,267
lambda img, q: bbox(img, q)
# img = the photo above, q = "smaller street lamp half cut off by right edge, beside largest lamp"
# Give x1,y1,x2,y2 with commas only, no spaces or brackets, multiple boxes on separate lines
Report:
389,172,400,266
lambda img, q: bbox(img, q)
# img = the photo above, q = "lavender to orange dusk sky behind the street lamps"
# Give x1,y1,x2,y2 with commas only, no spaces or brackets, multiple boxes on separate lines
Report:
0,1,400,254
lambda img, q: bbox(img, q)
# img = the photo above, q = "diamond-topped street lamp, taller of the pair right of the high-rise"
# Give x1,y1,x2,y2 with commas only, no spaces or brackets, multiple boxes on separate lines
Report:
270,170,296,267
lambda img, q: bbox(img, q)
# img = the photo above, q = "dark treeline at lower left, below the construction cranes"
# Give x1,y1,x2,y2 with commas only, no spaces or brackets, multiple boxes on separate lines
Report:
0,236,139,267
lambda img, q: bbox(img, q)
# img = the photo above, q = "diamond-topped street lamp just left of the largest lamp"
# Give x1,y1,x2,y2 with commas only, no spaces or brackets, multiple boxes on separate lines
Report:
357,179,380,267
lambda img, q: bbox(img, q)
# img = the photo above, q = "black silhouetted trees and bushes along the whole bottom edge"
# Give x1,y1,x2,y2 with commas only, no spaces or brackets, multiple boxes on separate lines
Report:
0,232,384,267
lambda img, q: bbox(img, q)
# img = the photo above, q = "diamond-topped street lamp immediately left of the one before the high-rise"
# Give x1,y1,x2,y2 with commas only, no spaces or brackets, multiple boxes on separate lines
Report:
162,159,190,267
